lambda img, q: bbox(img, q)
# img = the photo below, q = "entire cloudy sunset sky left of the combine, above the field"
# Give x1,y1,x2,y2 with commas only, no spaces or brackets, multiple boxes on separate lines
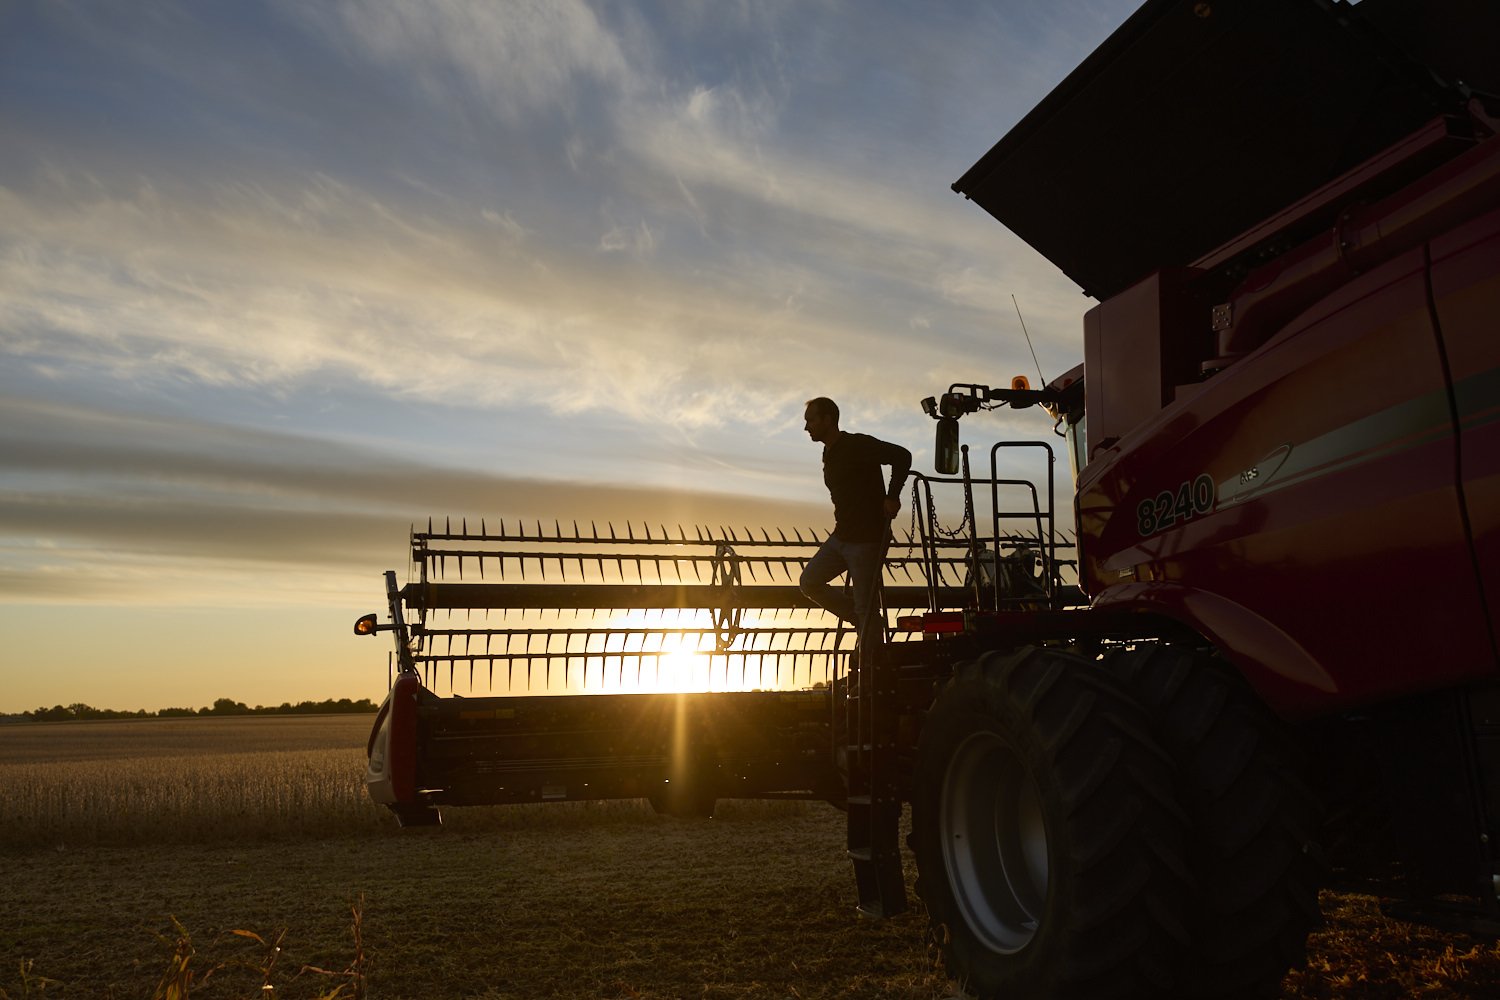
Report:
0,0,1136,712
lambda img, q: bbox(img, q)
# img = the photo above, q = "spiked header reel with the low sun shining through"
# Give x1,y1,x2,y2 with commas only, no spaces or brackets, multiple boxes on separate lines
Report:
356,519,965,694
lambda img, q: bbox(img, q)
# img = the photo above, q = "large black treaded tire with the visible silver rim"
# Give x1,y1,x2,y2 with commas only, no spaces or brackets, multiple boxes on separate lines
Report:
912,648,1188,1000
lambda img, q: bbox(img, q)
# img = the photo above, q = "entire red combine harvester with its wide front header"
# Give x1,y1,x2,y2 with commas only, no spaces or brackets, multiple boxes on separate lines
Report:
363,0,1500,1000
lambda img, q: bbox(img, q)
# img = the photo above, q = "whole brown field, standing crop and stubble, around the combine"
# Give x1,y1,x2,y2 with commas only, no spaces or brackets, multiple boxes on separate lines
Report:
0,718,1500,1000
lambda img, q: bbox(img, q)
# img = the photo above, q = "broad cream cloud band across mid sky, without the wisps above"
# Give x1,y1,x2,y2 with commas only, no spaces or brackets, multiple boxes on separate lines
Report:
0,152,1050,440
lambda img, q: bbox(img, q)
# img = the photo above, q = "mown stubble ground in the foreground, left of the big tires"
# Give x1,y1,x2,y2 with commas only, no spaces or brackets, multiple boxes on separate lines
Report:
0,805,951,1000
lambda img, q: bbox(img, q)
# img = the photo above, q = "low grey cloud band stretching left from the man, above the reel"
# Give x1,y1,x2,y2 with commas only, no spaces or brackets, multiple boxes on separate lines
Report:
0,399,825,604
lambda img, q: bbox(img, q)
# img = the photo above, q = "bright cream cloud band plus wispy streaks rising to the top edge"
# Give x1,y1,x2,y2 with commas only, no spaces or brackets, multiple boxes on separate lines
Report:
0,1,1116,437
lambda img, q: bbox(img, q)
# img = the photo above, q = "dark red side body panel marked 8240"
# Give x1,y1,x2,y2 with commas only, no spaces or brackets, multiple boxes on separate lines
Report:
1079,139,1500,717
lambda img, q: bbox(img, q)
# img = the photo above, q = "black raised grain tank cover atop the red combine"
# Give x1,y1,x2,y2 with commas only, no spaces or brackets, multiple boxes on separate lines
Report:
953,0,1500,300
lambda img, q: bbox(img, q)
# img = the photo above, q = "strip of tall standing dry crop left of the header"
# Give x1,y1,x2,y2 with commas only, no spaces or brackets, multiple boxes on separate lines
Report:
0,717,690,850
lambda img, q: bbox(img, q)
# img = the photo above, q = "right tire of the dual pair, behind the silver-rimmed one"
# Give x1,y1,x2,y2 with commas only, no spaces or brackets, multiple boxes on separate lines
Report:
1106,643,1323,1000
